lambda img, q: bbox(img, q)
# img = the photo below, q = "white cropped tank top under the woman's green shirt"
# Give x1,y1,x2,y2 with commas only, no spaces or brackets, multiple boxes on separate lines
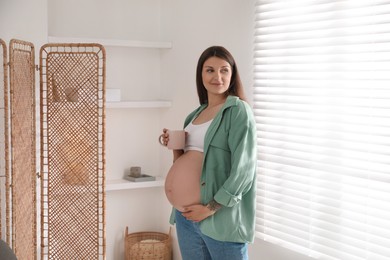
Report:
184,120,213,152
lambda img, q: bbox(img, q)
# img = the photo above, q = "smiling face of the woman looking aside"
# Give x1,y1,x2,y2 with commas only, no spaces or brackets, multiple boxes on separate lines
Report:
202,57,232,96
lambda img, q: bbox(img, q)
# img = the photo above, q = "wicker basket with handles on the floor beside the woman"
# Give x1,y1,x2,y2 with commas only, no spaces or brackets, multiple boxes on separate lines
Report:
125,227,172,260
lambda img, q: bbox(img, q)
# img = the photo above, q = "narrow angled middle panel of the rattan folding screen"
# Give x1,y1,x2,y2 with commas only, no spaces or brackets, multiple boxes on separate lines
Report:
9,40,37,259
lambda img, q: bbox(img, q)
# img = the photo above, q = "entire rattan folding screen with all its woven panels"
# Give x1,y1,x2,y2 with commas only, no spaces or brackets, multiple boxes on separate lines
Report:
0,39,106,260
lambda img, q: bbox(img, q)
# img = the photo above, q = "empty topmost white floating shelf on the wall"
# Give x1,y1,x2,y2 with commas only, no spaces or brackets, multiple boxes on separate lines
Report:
48,36,172,49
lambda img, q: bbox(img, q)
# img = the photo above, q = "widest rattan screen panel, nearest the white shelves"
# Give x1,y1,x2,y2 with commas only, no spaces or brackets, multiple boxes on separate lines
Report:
40,44,105,259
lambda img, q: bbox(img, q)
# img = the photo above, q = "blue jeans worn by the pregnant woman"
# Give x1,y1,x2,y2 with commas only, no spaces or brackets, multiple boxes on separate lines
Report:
175,210,248,260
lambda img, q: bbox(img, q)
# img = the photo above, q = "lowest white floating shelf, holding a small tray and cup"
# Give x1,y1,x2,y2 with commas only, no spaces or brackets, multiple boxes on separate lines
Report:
106,177,165,191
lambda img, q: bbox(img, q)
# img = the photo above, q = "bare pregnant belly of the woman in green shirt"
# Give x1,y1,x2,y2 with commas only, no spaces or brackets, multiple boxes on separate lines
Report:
165,150,203,211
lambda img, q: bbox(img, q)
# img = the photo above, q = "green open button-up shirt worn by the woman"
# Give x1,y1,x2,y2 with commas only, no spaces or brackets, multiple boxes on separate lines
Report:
170,96,256,243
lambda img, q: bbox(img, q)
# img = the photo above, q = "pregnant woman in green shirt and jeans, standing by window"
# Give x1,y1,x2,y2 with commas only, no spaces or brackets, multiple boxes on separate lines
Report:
162,46,256,260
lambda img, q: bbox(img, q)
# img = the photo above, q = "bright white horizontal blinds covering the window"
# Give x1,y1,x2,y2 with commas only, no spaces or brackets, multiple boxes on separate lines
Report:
254,0,390,260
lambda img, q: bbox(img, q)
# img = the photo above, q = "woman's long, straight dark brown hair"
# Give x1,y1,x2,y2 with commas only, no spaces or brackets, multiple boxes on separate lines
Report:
196,46,245,104
